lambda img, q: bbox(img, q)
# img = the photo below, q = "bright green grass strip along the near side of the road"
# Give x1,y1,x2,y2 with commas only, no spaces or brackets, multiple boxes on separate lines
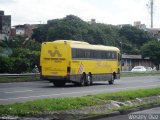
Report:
0,88,160,116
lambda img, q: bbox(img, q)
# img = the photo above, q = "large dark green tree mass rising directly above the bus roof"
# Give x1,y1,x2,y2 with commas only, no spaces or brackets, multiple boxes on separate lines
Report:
32,15,155,54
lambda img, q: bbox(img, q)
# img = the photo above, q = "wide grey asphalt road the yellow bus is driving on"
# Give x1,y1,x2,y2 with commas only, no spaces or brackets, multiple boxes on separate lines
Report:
0,76,160,104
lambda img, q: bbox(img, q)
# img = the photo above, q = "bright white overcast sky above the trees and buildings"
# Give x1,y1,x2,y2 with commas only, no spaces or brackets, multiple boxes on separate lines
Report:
0,0,160,28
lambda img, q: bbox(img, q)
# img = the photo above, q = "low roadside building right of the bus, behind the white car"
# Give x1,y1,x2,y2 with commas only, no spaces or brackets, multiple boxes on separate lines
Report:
122,54,155,71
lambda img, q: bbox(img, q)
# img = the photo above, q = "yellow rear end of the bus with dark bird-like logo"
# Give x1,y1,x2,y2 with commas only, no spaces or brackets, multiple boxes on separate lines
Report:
40,42,70,81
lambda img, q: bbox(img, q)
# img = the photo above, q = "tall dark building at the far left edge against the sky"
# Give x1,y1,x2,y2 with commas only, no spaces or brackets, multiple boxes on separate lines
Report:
0,11,11,40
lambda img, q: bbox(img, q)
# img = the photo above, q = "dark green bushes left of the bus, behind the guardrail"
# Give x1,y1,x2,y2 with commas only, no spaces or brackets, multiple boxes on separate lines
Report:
0,36,40,73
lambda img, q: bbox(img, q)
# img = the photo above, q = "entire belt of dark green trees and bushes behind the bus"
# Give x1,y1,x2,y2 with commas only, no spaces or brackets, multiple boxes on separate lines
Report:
0,15,160,73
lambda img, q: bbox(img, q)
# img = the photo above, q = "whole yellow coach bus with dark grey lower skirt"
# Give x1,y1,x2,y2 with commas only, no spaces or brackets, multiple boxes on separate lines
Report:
40,40,121,86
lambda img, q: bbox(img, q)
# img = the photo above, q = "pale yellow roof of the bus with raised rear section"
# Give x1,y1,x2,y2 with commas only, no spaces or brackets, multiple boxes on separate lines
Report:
47,40,119,51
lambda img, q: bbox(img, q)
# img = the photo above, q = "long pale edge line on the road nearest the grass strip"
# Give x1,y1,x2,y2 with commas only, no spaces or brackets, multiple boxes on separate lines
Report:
0,85,159,101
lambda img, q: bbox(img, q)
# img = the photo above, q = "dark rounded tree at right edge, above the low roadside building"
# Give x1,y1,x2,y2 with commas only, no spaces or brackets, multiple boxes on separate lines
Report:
141,40,160,69
